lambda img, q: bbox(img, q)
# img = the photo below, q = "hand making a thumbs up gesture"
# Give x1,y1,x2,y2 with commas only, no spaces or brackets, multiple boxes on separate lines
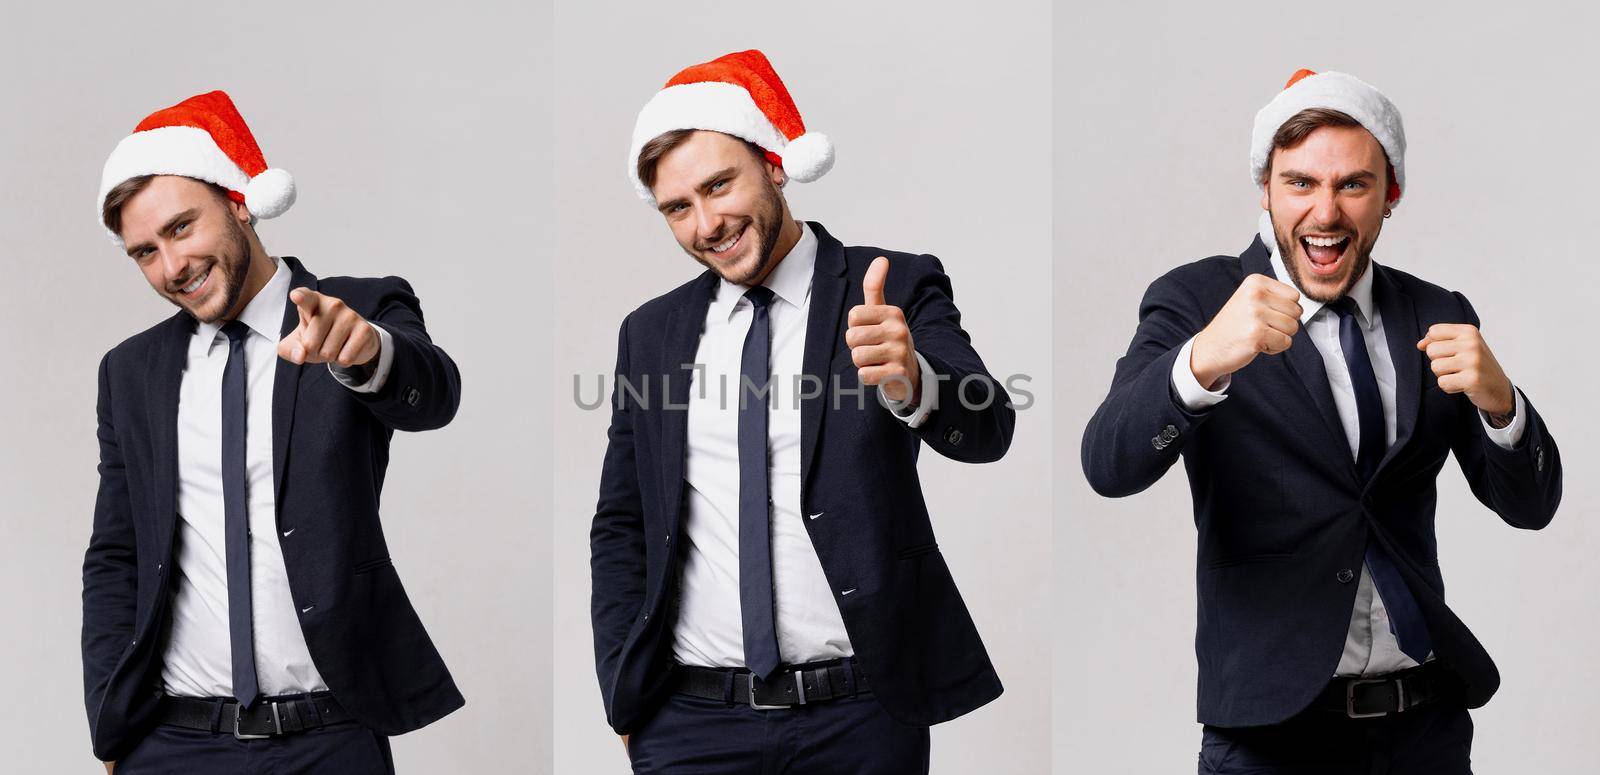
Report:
845,256,922,404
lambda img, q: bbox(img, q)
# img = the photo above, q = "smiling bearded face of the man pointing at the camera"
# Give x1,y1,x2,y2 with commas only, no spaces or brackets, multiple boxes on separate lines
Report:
107,175,272,323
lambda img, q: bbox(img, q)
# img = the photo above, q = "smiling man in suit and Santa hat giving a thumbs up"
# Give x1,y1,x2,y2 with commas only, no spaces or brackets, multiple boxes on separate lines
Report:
590,51,1014,775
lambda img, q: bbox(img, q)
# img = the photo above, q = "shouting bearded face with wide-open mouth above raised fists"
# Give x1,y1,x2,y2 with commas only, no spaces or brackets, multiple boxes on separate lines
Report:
1261,122,1392,303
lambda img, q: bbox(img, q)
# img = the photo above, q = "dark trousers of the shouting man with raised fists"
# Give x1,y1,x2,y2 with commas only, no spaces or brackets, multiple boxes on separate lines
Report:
1200,703,1472,775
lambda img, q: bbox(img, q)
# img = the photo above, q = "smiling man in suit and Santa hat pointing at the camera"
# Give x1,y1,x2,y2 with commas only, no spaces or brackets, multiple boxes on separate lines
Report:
83,91,462,775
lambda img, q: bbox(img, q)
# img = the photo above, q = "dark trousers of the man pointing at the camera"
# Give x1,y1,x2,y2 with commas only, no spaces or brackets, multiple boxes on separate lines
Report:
117,722,395,775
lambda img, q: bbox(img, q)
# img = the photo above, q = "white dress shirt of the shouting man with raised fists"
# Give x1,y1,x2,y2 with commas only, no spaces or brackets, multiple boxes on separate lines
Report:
1173,213,1526,676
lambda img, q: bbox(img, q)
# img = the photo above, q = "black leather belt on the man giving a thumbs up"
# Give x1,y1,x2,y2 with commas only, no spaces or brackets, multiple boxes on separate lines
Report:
674,658,867,711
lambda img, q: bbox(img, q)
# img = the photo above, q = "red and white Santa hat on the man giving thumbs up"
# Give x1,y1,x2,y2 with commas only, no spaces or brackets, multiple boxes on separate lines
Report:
627,50,834,207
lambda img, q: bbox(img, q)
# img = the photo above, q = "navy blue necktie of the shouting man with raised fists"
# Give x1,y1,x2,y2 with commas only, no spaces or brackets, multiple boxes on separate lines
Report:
1330,296,1434,665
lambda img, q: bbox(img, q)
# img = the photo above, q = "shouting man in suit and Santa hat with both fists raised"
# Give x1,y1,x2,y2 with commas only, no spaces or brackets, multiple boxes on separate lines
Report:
1083,70,1562,773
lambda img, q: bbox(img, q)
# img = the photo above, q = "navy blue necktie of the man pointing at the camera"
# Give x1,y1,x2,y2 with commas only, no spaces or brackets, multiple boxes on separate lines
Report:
222,320,261,708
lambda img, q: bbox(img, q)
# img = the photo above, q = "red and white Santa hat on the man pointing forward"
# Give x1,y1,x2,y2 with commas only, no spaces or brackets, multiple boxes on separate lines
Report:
94,91,294,245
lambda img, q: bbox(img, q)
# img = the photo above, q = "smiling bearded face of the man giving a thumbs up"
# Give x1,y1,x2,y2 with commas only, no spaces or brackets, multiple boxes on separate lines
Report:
651,131,800,285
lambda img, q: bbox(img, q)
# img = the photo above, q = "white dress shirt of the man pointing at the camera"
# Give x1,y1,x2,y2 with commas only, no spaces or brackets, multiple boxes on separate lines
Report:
162,261,394,697
